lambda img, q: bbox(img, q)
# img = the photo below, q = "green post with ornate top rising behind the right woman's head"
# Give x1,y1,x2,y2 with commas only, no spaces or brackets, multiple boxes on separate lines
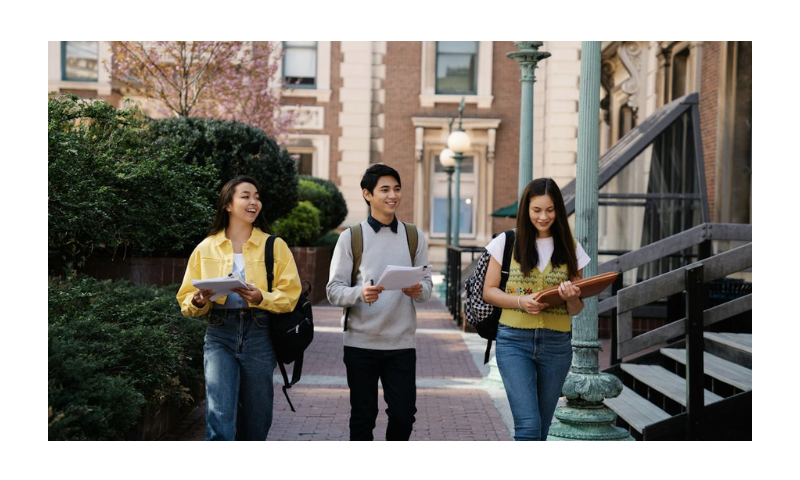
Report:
506,42,550,197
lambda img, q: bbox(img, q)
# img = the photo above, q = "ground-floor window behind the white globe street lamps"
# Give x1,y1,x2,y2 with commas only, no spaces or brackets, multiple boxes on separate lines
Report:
430,152,478,238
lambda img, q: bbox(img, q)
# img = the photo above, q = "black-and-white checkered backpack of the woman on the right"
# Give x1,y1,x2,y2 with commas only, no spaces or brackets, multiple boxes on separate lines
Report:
464,230,516,364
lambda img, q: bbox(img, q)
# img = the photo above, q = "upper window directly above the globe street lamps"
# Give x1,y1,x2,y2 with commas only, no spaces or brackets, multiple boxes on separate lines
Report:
436,42,478,95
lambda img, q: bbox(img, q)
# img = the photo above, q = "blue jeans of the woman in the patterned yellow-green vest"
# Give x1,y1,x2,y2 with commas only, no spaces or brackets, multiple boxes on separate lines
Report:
497,324,572,440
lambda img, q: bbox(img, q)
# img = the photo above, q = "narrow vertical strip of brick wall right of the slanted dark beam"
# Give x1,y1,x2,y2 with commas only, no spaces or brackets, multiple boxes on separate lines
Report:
700,42,724,222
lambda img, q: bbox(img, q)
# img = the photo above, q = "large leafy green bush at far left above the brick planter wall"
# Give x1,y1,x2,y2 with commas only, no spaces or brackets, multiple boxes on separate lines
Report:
47,94,217,274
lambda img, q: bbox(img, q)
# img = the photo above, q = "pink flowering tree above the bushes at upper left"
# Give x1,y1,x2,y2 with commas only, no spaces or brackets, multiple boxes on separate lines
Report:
106,42,294,138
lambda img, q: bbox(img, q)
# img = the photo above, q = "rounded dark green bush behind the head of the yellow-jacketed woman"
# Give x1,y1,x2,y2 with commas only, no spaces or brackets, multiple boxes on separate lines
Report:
150,117,298,227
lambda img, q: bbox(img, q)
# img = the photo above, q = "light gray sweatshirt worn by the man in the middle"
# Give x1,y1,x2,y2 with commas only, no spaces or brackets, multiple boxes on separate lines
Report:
326,221,433,350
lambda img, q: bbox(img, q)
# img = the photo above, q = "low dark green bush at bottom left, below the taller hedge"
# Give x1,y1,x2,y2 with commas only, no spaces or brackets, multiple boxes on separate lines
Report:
48,277,205,440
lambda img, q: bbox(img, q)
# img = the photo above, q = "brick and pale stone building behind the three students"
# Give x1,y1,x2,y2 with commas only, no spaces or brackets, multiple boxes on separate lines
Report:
48,41,751,268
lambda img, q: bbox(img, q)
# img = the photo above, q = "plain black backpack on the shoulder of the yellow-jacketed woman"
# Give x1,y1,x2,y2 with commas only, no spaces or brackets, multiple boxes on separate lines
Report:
264,235,314,412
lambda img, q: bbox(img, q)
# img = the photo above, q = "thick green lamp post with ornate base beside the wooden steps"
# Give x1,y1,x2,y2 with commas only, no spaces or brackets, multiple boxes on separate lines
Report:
547,42,633,440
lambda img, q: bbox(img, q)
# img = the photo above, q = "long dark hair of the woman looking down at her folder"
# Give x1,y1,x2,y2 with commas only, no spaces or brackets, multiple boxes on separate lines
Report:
514,178,578,279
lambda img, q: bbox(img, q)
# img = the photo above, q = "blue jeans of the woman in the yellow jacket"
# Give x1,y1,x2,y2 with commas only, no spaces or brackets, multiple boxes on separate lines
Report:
203,309,277,440
